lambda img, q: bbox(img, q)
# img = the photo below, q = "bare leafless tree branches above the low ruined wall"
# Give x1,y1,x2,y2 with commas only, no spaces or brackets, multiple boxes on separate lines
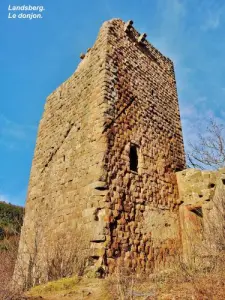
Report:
187,119,225,170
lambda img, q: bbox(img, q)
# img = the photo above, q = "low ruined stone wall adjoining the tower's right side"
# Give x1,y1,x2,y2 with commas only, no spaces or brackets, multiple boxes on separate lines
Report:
177,169,225,269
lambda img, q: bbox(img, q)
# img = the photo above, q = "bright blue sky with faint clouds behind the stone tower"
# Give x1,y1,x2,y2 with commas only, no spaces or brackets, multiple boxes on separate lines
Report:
0,0,225,205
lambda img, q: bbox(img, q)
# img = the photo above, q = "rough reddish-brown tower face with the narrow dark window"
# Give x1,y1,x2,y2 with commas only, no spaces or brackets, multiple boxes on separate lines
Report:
105,20,185,270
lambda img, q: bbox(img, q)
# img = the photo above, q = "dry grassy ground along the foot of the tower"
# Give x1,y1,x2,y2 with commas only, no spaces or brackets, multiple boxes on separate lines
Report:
27,271,225,300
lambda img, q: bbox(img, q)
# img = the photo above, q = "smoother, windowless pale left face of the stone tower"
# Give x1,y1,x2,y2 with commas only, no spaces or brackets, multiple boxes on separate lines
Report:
14,24,110,287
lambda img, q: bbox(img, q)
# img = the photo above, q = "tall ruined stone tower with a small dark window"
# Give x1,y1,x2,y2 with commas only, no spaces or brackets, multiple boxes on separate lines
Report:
14,19,185,286
